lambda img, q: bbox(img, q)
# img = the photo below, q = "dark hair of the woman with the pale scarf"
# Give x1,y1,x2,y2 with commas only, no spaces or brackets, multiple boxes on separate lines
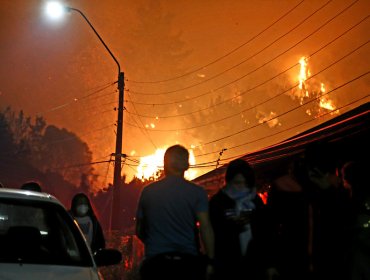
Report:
225,159,256,187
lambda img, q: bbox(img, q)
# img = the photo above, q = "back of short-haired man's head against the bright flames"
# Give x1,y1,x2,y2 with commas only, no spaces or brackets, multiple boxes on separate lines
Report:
164,145,189,176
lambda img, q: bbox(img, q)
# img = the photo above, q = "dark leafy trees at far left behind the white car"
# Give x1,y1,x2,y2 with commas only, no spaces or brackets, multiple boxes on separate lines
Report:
0,107,96,191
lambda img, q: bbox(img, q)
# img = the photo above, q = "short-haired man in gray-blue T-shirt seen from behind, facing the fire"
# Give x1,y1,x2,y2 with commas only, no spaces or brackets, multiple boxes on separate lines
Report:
136,145,214,280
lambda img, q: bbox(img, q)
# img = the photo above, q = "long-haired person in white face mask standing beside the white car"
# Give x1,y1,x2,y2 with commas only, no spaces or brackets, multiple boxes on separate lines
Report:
70,193,105,252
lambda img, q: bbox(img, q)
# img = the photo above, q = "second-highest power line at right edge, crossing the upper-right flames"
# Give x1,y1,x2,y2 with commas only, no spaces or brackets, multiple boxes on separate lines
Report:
123,40,370,132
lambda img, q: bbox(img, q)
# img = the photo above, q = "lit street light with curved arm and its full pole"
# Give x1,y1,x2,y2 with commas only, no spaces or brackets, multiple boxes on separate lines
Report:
46,1,125,230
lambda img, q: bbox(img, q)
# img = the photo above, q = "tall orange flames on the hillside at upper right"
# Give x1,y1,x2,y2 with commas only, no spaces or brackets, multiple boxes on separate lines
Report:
290,57,339,117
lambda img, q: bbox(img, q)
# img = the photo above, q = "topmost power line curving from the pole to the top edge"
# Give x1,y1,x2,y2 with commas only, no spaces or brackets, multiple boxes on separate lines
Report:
126,0,304,84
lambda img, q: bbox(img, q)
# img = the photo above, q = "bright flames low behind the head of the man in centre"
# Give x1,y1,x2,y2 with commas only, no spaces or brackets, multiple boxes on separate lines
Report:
136,148,197,181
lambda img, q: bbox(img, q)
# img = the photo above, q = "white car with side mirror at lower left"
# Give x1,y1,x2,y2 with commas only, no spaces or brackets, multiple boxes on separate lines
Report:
0,189,122,280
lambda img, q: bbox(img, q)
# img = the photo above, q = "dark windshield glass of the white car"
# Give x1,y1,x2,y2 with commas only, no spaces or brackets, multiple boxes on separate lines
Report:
0,198,92,266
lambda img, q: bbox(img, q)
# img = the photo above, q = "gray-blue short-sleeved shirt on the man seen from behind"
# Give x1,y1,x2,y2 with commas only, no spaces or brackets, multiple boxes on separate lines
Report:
137,176,208,257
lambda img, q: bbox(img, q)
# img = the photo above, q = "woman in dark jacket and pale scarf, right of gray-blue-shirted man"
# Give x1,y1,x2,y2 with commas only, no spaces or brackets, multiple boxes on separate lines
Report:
210,160,264,279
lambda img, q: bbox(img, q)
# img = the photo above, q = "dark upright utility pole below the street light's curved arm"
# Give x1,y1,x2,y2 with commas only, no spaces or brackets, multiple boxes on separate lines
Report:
111,72,125,230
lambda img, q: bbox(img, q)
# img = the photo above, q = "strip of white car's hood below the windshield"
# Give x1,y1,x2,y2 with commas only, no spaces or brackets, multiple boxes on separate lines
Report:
0,263,99,280
